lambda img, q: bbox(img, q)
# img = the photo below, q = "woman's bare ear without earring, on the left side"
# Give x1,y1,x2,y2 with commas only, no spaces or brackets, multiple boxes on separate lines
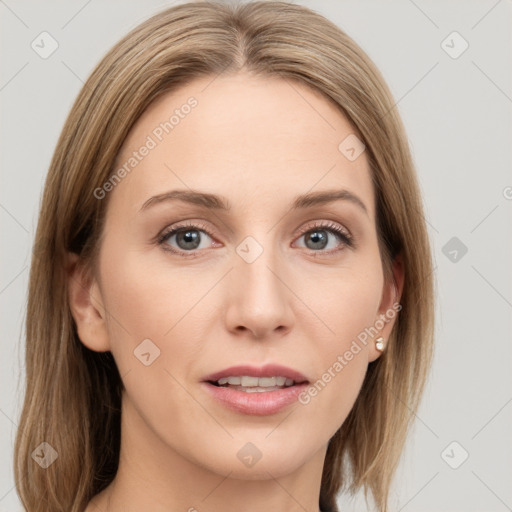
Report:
66,253,110,352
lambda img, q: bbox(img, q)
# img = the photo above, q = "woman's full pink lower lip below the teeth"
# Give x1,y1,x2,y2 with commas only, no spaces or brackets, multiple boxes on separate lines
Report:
203,382,308,416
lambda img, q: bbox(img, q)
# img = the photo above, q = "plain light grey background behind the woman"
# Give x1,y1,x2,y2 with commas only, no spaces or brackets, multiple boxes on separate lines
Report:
0,0,512,512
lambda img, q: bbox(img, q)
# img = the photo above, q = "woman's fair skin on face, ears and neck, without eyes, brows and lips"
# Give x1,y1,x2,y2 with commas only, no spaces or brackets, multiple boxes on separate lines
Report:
70,72,403,512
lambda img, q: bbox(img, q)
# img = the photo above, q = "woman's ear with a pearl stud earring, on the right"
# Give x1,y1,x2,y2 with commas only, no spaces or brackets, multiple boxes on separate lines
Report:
368,253,405,362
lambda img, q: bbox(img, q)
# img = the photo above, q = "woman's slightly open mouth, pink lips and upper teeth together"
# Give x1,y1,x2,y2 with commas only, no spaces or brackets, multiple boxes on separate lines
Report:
203,365,309,416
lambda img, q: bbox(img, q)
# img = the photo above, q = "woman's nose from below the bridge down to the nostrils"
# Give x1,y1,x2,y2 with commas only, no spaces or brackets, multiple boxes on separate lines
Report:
225,243,294,339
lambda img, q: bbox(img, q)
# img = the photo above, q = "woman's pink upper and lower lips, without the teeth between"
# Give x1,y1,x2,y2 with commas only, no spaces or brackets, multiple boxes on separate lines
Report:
203,364,308,416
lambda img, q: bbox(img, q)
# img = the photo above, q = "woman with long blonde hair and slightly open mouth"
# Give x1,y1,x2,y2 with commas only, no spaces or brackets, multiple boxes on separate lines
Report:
15,2,433,512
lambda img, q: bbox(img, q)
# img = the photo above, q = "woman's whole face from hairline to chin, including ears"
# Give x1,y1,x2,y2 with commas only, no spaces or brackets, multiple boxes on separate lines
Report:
71,73,402,479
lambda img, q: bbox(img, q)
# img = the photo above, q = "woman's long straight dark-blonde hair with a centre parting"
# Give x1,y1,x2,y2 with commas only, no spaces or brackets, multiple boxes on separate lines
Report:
14,1,434,512
